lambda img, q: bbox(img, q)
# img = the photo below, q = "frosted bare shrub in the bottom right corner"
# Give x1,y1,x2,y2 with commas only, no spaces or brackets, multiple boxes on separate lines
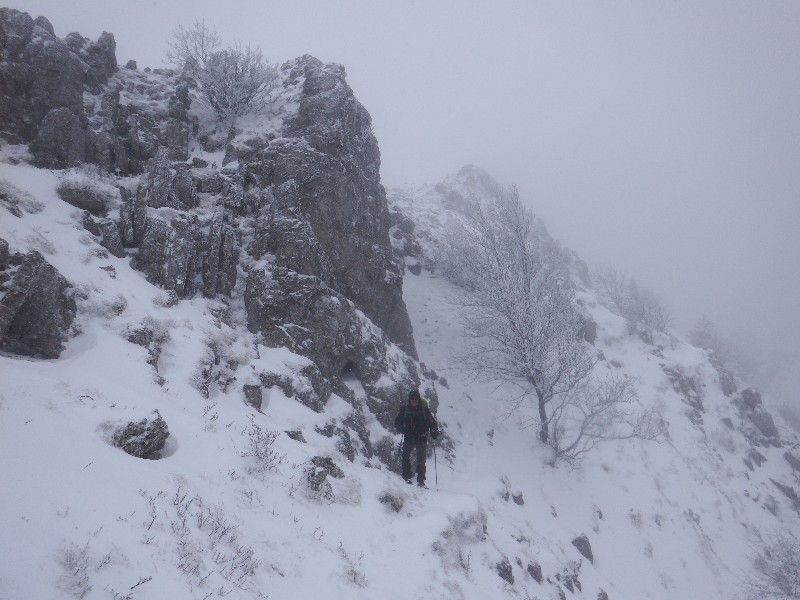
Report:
744,531,800,600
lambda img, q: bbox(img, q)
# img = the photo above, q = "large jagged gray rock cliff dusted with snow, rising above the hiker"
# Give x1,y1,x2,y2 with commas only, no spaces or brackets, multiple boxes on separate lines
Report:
0,8,435,447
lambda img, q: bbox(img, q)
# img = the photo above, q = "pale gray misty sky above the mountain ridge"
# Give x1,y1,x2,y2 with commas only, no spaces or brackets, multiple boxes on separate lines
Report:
6,0,800,400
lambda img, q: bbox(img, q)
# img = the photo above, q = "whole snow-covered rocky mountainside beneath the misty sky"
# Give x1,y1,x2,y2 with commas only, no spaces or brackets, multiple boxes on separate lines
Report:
0,11,800,599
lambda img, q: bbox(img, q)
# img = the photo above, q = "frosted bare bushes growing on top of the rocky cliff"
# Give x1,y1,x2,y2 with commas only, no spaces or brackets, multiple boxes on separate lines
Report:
167,21,278,121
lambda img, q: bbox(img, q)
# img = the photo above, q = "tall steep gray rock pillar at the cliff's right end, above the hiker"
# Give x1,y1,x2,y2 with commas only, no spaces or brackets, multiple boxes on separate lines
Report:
252,56,416,357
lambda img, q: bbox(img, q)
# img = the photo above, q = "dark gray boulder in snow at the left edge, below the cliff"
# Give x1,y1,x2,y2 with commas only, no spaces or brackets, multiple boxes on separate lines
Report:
0,244,77,358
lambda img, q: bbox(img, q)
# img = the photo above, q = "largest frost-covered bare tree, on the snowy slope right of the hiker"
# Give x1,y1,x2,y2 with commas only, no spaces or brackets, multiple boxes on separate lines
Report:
441,188,664,459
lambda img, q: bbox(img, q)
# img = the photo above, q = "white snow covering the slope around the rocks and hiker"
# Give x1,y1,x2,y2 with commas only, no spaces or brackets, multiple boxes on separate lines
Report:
0,155,800,600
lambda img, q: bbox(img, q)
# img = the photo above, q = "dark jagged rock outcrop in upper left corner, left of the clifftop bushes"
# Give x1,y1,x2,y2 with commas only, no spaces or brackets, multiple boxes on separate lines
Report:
0,8,192,174
